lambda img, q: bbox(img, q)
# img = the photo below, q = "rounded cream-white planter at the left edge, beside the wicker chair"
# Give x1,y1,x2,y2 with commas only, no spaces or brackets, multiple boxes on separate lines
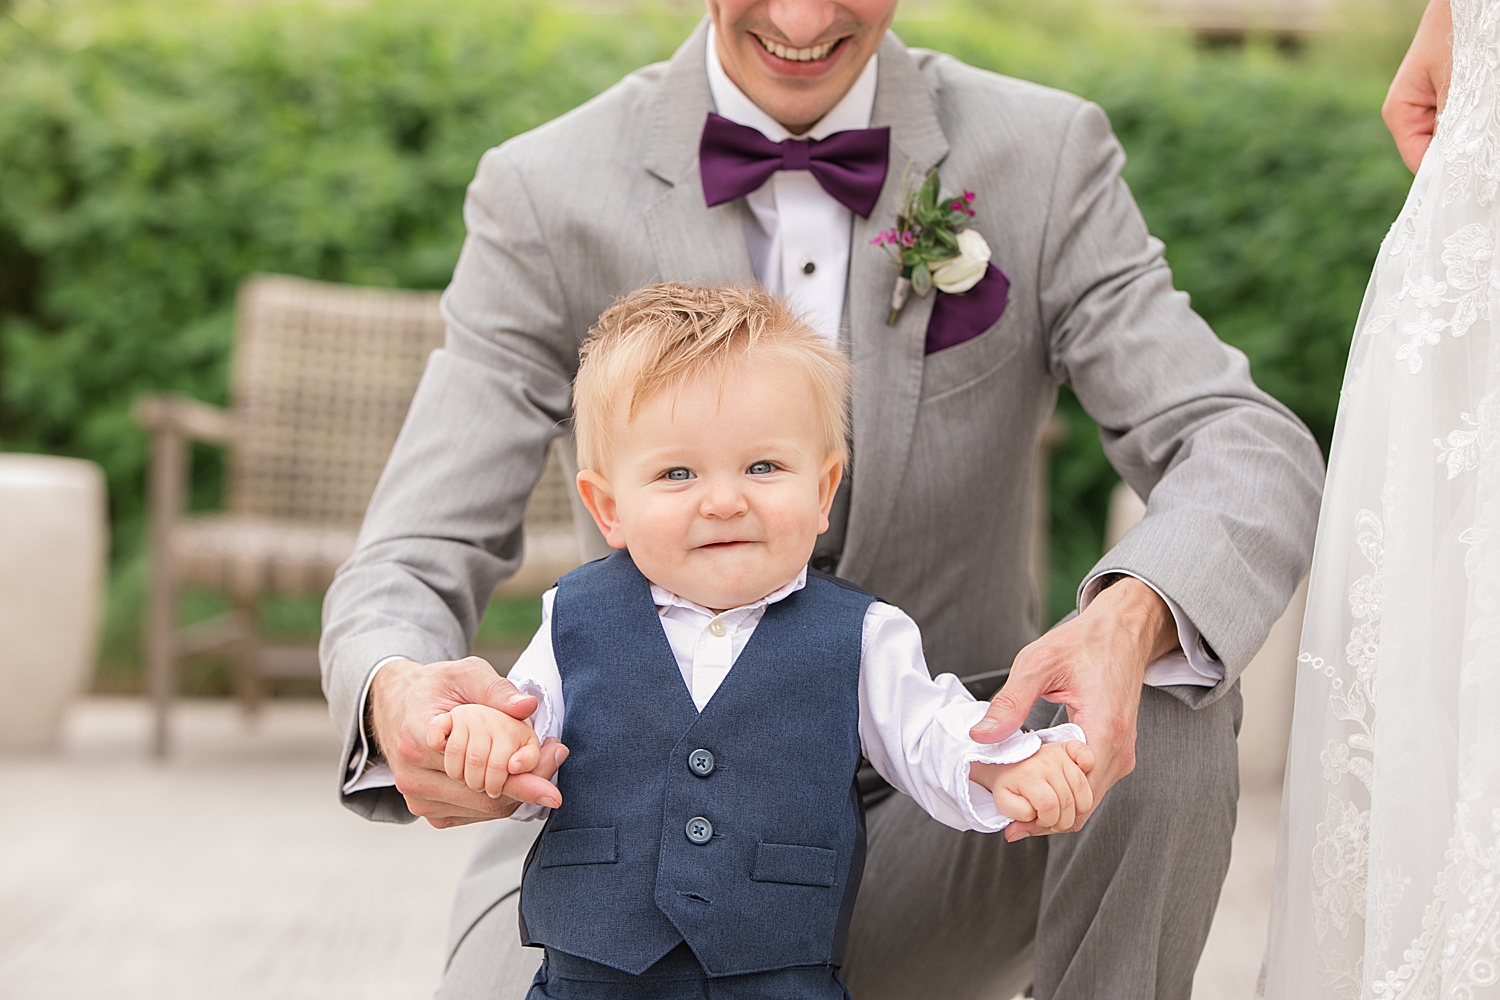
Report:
0,454,108,748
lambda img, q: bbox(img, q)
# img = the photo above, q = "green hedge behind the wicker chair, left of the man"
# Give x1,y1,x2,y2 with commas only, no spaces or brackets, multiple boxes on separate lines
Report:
0,0,689,552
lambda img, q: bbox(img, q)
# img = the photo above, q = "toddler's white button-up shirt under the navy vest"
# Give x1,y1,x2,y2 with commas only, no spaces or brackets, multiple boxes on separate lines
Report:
509,570,1083,834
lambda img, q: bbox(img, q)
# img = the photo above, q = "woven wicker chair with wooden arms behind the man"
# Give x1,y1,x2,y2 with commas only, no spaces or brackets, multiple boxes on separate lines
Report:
135,276,579,754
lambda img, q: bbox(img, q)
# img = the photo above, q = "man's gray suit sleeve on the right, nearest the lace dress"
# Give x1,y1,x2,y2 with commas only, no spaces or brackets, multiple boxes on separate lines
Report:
1038,103,1323,705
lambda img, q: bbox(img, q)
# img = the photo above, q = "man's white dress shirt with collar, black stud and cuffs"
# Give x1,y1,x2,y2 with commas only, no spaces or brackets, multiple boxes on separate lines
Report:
344,37,1224,793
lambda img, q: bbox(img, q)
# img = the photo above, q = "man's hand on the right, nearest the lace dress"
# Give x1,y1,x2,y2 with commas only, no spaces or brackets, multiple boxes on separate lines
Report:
969,577,1178,841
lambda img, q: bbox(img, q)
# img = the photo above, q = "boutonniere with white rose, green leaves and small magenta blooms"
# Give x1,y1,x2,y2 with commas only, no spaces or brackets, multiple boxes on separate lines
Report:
870,165,990,325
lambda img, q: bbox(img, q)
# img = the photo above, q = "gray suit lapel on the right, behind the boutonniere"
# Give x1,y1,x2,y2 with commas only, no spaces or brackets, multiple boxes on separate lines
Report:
839,34,948,580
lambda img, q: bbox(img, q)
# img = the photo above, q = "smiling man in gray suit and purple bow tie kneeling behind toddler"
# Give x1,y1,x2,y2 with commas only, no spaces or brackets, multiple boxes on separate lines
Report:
323,0,1322,1000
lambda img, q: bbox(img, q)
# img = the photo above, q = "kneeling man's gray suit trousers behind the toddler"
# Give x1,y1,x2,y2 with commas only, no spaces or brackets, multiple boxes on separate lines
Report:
438,684,1241,1000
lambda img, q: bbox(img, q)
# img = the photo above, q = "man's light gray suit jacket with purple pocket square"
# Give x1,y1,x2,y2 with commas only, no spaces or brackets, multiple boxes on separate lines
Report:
323,17,1323,947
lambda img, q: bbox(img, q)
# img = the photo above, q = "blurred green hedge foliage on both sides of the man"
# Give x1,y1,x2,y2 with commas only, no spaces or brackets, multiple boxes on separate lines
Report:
0,0,1419,687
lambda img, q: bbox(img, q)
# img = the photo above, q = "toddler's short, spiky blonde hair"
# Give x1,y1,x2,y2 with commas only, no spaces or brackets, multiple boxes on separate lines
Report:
573,283,849,469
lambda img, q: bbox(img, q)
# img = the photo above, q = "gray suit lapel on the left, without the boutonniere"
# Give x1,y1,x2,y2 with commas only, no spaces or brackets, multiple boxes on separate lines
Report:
645,18,756,285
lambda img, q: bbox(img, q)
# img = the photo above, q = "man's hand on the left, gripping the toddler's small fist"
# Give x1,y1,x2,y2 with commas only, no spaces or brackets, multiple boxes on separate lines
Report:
369,657,567,829
